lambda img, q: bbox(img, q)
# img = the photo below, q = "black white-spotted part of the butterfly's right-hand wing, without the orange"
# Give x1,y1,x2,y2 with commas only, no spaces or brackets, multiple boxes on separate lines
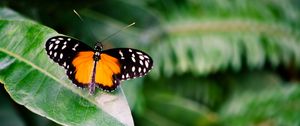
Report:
102,48,153,81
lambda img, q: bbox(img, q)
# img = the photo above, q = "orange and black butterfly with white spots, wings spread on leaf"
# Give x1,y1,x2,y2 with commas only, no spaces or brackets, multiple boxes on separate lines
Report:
45,36,153,94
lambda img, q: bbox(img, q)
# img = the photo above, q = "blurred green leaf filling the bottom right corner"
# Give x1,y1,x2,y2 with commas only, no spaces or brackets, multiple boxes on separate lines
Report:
220,84,300,126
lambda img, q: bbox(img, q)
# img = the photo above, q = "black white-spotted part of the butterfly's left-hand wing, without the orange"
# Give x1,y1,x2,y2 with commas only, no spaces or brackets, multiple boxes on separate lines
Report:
45,36,93,87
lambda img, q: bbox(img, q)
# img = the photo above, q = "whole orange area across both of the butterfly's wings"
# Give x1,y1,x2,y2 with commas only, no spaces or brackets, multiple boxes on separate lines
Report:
72,51,121,87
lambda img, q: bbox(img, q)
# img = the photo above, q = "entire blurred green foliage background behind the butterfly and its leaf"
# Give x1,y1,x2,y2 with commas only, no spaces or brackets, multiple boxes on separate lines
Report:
0,0,300,126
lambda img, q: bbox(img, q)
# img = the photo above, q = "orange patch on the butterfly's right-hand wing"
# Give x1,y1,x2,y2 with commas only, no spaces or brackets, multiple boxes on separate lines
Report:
95,54,121,87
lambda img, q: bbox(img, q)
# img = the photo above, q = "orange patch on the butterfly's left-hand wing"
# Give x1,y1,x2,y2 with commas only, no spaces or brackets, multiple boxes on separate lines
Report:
72,51,94,85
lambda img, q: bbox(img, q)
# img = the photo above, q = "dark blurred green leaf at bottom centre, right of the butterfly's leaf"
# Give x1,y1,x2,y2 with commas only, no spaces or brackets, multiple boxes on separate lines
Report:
143,92,218,126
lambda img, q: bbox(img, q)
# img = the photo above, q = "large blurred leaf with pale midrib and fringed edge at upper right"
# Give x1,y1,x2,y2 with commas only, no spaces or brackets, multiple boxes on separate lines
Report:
150,0,300,78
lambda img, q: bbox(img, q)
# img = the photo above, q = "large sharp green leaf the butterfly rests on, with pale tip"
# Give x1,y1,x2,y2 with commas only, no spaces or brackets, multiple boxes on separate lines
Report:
0,9,133,126
